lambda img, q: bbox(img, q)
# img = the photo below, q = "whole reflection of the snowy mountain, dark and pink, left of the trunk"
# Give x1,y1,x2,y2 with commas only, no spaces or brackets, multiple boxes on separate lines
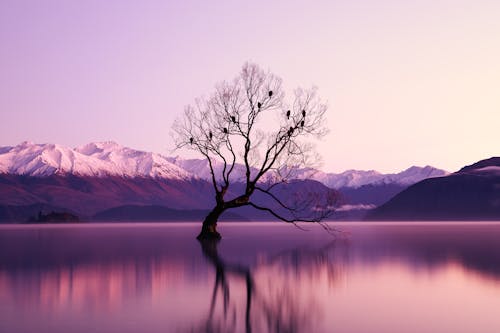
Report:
0,226,207,316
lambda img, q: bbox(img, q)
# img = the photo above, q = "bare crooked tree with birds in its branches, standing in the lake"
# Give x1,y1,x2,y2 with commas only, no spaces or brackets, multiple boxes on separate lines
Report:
173,63,335,239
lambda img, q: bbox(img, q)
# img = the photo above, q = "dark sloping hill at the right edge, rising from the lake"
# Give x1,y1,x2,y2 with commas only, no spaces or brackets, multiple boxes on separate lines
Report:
367,157,500,220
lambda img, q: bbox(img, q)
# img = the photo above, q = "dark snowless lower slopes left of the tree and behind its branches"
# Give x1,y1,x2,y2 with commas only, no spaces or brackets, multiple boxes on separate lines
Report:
0,174,340,223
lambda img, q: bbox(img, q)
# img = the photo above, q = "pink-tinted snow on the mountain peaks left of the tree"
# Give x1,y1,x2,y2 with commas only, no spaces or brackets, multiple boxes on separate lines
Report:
0,142,193,179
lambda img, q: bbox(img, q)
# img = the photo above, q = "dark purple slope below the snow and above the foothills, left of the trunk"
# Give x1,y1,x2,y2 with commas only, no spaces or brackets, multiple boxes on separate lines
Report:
0,174,214,219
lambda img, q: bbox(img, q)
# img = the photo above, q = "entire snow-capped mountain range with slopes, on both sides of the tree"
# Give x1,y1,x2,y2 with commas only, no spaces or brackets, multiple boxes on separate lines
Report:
0,142,446,220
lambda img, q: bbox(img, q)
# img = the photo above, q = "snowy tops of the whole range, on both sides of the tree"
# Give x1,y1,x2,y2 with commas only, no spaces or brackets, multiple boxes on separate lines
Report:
0,142,448,189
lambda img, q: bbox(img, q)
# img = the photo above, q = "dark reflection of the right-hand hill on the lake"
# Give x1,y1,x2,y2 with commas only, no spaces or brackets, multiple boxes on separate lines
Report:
352,222,500,282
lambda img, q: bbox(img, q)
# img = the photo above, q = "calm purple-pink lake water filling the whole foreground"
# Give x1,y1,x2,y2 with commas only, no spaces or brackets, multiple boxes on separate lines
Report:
0,223,500,333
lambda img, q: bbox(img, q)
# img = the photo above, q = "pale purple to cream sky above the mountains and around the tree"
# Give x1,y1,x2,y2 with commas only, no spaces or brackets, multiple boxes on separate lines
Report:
0,0,500,171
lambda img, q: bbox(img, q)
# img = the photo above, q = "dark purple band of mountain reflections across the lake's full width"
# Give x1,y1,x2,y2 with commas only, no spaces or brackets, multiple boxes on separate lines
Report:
0,223,500,279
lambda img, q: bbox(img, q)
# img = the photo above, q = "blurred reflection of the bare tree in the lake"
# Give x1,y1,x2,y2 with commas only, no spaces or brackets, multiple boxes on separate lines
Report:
191,240,347,333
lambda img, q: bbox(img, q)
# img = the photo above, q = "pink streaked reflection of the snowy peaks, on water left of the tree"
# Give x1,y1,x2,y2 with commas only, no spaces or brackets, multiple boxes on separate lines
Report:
0,261,185,312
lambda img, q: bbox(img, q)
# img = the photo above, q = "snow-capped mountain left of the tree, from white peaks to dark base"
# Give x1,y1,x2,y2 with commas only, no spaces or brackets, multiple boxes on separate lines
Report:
0,142,338,222
